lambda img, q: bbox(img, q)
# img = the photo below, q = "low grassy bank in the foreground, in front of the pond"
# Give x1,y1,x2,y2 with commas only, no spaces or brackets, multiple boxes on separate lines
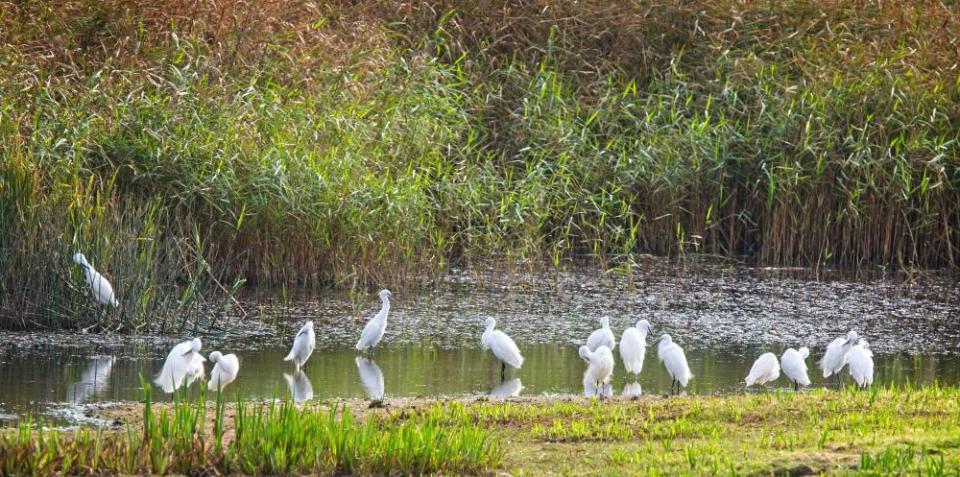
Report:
0,387,960,476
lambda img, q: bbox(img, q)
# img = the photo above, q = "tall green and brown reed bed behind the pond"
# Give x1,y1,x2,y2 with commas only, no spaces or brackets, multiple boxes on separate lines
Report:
0,0,960,331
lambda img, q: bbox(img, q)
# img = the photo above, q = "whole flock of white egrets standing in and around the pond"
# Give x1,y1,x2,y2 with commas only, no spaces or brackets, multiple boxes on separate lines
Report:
73,253,873,397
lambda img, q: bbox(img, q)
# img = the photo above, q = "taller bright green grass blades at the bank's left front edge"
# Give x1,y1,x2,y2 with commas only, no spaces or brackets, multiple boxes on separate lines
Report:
0,386,504,475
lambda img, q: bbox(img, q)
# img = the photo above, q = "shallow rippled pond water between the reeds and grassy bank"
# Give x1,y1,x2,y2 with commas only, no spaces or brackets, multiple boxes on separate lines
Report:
0,262,960,425
